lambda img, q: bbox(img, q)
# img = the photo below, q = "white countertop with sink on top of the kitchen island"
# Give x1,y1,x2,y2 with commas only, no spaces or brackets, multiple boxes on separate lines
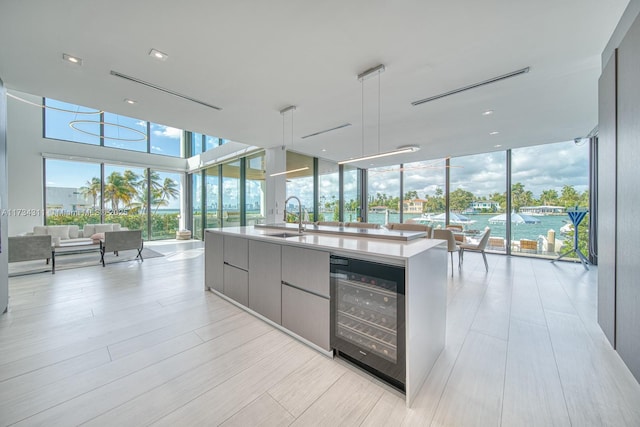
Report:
205,226,446,260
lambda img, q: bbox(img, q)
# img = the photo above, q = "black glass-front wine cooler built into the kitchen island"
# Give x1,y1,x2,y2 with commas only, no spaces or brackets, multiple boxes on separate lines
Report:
331,255,406,391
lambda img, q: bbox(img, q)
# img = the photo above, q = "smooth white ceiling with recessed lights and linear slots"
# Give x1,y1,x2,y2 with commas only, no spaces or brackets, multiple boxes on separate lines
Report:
0,0,628,166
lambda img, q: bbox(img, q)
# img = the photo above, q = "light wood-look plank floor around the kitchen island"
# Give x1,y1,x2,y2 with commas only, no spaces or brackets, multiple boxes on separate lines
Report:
0,241,640,426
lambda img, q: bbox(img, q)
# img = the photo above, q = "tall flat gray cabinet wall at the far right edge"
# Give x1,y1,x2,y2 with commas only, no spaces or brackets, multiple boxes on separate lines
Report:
598,10,640,380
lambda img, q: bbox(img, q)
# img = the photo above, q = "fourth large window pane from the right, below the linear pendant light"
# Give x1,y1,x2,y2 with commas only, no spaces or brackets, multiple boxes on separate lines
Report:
367,166,401,224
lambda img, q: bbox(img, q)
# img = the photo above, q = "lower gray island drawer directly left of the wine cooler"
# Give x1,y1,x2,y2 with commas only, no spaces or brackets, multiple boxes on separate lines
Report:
282,283,331,351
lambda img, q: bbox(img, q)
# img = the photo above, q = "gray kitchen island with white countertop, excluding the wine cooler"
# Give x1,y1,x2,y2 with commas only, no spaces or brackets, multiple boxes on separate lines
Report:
205,227,447,406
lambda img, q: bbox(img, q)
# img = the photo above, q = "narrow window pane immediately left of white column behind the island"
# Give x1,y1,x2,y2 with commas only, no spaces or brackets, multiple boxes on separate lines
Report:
245,153,266,225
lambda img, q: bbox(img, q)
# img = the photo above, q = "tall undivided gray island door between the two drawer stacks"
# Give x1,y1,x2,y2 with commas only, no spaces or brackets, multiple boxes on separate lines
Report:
249,240,282,324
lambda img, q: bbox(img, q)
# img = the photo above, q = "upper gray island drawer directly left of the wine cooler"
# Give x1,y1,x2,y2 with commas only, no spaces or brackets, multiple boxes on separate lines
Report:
282,246,329,298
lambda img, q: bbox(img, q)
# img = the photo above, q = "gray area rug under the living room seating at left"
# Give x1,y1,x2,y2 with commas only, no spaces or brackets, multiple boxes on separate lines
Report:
9,248,164,277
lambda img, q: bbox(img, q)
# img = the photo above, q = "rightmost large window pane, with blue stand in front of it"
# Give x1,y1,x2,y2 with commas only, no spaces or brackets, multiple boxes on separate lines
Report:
511,141,589,258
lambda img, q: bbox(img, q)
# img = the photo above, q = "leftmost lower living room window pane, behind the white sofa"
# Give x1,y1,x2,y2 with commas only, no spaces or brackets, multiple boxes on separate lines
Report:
45,159,101,228
